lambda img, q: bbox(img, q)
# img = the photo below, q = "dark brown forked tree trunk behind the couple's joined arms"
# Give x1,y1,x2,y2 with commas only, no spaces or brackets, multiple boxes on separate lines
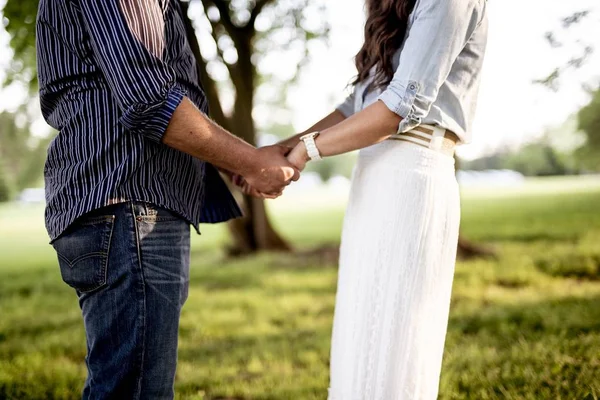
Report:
180,2,292,255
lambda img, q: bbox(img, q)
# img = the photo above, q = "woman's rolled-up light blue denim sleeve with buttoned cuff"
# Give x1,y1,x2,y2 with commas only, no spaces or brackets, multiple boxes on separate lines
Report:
378,0,485,132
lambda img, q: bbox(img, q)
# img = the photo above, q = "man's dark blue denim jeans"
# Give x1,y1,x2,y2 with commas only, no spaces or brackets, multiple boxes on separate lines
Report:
52,202,190,400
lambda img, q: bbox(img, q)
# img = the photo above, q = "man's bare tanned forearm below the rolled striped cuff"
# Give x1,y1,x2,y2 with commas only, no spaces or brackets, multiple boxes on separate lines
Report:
162,98,256,175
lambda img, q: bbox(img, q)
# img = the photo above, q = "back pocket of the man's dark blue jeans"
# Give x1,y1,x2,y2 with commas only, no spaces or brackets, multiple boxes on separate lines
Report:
52,215,115,293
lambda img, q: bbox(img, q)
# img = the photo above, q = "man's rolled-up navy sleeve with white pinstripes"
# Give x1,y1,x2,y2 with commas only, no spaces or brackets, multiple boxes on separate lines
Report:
79,0,186,142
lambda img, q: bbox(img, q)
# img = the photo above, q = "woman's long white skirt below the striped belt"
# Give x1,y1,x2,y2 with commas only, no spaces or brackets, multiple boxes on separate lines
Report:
329,140,460,400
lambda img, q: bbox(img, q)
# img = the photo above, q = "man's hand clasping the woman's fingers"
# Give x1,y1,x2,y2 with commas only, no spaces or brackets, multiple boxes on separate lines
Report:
238,145,300,198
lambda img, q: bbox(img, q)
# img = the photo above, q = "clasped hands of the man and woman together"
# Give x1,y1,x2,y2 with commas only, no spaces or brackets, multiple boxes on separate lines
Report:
232,142,308,199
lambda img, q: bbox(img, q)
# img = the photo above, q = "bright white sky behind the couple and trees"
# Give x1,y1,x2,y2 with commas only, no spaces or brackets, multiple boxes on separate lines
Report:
0,0,600,158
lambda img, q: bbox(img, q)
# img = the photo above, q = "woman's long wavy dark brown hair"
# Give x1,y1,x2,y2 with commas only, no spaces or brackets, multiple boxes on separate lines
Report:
354,0,416,87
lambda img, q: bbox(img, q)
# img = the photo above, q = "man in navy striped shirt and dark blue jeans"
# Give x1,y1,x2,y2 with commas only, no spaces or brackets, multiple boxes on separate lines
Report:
36,0,298,399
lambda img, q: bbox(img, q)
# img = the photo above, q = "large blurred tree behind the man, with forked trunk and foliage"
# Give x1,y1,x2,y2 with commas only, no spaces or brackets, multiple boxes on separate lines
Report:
4,0,328,254
